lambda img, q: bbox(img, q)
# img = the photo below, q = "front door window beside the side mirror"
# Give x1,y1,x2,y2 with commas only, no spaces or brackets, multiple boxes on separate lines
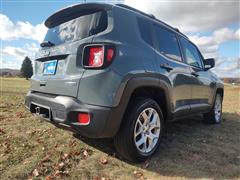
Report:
180,38,202,68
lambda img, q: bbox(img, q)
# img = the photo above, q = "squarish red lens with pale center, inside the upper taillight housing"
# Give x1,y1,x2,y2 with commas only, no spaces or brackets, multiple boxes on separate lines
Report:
88,47,104,67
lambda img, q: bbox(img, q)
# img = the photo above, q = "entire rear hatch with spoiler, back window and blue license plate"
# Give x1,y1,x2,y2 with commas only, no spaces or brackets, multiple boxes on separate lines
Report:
31,4,112,97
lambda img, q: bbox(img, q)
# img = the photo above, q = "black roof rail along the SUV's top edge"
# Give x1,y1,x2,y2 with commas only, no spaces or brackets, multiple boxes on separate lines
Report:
116,4,188,39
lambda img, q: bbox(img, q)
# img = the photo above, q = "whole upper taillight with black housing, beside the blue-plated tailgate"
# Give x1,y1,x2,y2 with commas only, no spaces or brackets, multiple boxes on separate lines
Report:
83,45,115,69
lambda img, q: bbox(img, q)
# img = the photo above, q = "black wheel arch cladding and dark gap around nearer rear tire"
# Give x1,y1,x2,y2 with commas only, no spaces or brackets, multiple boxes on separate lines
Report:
107,77,171,135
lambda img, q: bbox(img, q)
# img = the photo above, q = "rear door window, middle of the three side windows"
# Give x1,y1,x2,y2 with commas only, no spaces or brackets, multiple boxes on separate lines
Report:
154,25,182,61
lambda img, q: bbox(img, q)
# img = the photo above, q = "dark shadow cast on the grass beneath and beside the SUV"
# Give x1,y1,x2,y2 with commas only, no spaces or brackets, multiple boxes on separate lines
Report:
75,113,240,179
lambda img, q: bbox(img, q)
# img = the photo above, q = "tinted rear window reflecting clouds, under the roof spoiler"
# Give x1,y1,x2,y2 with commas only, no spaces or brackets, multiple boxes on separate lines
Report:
44,11,108,45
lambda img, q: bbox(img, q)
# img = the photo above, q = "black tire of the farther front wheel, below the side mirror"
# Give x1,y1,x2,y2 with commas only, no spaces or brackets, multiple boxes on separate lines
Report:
203,94,222,124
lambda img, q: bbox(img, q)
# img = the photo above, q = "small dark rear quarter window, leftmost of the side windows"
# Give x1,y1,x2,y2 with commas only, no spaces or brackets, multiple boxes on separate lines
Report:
138,18,153,46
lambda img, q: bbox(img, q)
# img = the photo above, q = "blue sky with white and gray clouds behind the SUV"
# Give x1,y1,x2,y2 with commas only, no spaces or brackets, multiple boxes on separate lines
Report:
0,0,240,77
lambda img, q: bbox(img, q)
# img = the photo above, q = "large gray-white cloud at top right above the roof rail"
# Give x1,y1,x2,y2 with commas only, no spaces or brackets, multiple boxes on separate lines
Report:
124,0,239,33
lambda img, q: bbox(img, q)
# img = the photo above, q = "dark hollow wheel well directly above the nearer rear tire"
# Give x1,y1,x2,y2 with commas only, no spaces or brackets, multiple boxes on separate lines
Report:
126,87,168,121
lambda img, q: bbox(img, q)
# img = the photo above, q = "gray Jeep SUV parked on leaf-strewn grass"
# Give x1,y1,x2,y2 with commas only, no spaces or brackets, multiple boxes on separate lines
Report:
25,3,224,161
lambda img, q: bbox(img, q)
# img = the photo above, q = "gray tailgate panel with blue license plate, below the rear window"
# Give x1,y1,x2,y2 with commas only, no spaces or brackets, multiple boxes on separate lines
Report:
31,42,84,97
